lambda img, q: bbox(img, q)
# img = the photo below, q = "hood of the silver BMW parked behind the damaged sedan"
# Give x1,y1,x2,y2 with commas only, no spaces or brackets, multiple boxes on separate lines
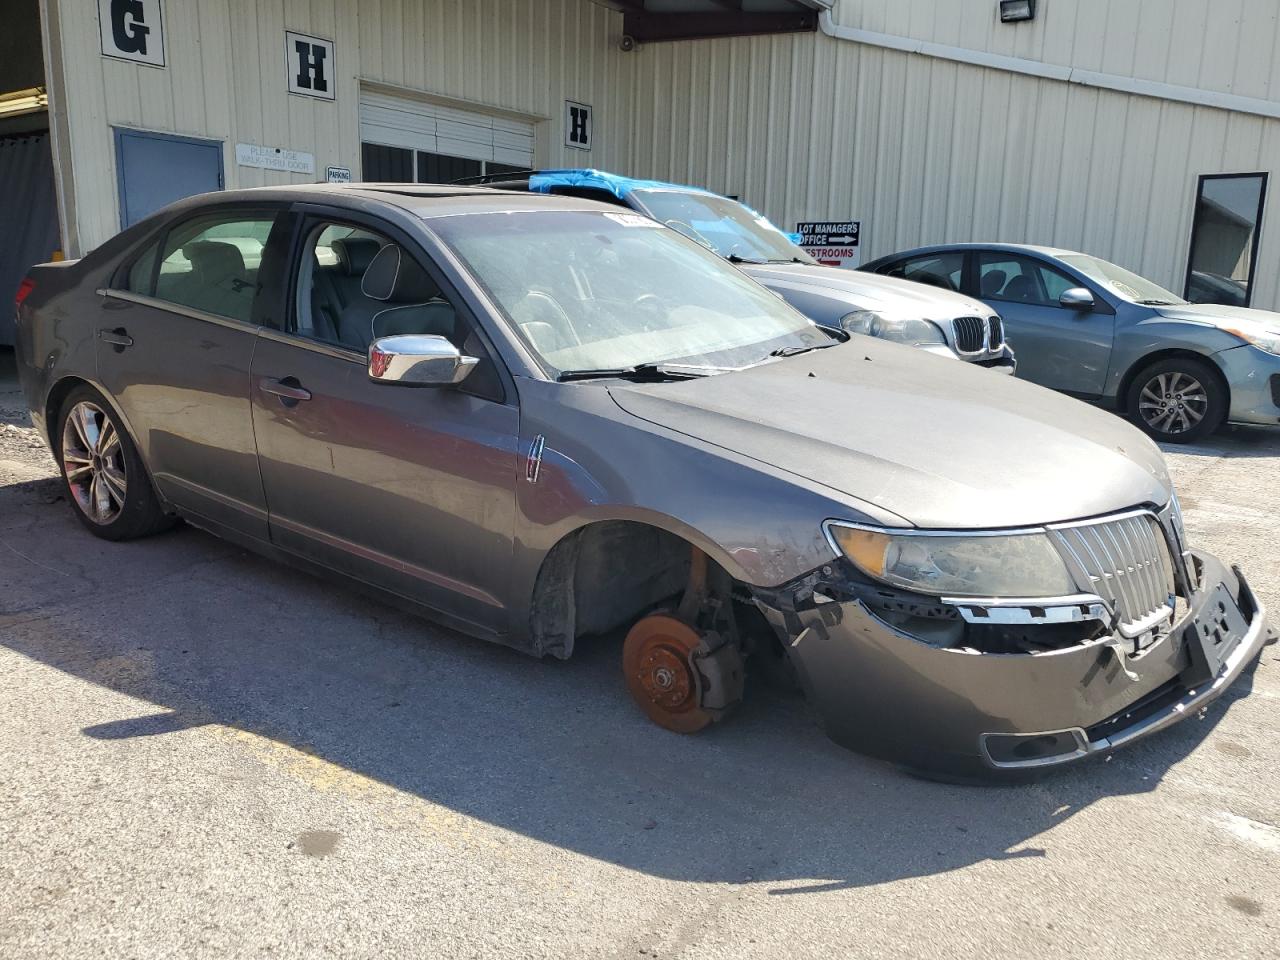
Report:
742,264,992,320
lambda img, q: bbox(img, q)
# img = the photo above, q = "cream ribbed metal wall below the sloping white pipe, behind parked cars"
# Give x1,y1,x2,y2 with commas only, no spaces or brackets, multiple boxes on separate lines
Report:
622,29,1280,308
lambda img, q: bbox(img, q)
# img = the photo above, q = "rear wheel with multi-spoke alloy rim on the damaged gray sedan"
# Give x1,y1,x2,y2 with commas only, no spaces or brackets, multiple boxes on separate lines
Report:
54,384,174,540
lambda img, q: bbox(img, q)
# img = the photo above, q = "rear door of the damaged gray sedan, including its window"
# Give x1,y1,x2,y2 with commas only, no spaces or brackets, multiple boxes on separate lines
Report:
96,206,288,539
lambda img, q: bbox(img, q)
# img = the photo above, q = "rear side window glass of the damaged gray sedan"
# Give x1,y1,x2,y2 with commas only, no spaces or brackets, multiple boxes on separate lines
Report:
128,212,275,323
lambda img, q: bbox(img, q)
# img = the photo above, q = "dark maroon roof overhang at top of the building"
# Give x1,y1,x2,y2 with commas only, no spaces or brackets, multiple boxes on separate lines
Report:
609,0,835,44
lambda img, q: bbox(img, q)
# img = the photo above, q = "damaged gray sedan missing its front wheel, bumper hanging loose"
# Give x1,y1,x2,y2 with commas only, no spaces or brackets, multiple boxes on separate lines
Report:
17,184,1266,776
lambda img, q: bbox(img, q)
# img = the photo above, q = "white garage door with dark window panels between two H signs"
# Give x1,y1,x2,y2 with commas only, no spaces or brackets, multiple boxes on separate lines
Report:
360,90,534,183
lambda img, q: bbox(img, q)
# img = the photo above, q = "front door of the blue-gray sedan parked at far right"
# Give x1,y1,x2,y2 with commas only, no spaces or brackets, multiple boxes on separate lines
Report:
972,250,1115,397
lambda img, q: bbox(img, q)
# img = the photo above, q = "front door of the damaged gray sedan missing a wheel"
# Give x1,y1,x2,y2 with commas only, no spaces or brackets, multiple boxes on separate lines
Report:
251,219,520,632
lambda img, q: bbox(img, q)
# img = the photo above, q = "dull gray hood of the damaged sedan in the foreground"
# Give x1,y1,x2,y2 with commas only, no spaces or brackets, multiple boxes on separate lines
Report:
609,337,1171,529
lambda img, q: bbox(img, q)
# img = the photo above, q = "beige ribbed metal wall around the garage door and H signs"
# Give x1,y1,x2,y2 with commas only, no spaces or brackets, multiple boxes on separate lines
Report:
49,0,631,252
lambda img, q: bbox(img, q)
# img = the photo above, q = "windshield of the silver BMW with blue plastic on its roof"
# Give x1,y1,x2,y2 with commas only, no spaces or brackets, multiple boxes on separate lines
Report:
631,189,818,264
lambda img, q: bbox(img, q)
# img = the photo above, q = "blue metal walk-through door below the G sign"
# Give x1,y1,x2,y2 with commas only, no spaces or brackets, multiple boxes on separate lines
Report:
115,128,223,228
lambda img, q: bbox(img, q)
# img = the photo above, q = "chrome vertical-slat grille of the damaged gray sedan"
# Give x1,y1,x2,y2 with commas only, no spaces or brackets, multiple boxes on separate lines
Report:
1050,512,1175,636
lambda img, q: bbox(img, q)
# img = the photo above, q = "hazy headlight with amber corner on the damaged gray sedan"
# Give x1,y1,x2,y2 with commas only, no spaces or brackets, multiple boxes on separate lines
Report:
827,522,1079,598
